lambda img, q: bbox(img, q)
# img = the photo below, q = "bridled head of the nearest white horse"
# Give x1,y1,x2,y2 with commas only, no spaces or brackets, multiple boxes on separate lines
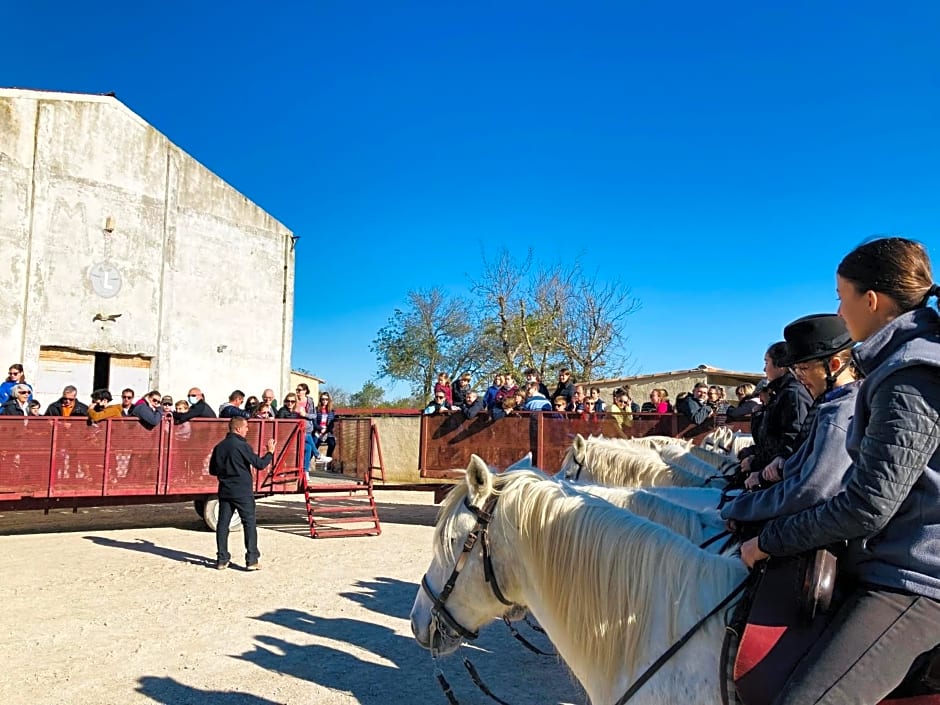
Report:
411,455,519,655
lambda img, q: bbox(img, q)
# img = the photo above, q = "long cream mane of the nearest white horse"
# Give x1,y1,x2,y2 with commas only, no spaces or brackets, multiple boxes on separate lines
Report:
478,470,745,683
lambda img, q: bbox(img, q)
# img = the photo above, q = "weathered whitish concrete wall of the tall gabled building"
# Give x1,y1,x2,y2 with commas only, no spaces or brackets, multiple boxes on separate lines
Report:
0,89,294,405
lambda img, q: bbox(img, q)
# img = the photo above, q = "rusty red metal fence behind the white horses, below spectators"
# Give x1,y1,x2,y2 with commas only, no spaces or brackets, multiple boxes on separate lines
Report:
419,413,751,479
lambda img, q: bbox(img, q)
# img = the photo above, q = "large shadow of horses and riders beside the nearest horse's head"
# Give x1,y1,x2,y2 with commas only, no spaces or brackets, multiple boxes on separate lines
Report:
237,577,585,705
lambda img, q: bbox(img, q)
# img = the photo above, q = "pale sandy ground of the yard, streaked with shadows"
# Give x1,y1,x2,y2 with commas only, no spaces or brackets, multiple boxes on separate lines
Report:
0,491,587,705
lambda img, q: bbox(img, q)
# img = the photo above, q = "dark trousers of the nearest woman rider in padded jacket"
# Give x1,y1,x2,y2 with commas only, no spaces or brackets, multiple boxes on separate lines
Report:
774,585,940,705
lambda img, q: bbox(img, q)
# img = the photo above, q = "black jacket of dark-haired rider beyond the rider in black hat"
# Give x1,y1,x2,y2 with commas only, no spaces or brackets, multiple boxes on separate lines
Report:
751,372,813,472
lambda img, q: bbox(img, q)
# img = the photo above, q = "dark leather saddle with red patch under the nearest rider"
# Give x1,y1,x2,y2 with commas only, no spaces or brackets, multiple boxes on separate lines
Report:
721,549,940,705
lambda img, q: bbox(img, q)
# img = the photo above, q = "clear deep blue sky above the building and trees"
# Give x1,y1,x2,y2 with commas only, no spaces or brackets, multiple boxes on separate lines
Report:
7,0,940,394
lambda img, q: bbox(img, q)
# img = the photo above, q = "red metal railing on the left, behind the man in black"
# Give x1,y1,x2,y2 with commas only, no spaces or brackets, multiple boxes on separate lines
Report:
0,416,304,509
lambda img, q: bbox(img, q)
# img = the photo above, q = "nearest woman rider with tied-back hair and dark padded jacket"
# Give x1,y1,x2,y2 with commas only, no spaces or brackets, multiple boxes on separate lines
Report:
741,237,940,705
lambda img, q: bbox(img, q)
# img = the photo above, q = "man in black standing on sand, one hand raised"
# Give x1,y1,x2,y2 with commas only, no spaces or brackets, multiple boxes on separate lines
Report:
209,417,276,570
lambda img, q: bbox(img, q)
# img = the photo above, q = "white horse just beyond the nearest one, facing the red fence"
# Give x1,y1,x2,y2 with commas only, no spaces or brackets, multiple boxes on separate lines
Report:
556,434,715,487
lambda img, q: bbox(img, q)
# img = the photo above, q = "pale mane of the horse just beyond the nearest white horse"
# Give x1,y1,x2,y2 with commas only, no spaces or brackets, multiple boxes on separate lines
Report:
562,440,713,487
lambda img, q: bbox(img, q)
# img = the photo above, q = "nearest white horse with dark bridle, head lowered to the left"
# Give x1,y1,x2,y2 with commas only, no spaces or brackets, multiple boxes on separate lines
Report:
411,456,747,705
